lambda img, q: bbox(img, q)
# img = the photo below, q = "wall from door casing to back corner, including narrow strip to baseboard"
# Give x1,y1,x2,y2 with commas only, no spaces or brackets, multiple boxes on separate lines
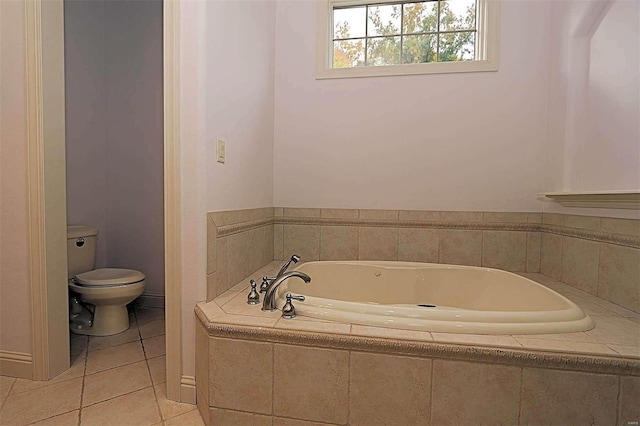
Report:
180,0,275,376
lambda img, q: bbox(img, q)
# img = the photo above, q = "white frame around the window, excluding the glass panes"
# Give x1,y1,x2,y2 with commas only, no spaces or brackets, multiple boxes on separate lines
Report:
316,0,500,80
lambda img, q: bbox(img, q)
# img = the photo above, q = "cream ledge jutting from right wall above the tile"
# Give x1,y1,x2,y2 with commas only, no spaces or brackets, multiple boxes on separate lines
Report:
544,189,640,210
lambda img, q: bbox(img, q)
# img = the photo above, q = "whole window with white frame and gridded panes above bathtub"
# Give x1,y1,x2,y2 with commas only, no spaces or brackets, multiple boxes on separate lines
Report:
316,0,499,78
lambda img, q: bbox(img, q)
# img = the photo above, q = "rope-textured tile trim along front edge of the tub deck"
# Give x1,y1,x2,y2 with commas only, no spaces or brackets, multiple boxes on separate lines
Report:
195,307,640,376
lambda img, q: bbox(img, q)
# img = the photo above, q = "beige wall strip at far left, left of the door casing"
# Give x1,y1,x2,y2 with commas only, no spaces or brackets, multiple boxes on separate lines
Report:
0,1,31,353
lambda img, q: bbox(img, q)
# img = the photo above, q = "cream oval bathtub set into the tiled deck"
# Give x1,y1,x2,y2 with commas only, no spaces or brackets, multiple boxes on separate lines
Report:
277,261,594,334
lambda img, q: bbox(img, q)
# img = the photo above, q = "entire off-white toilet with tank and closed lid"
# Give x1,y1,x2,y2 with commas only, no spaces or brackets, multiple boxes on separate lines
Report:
67,226,145,336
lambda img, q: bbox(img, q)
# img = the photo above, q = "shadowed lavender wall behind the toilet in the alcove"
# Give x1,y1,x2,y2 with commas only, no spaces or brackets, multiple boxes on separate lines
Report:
65,0,164,293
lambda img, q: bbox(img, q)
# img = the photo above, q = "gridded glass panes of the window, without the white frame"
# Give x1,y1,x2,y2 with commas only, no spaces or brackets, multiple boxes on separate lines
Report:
332,0,477,68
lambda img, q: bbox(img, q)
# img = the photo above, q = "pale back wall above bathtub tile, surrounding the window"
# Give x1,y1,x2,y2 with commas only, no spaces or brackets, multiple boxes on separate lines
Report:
274,1,550,211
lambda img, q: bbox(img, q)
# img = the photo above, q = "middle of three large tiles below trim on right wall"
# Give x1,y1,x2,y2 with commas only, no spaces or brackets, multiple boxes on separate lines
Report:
562,237,599,294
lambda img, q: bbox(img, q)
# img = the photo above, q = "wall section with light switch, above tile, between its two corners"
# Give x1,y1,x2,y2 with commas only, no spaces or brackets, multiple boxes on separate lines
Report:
205,1,275,211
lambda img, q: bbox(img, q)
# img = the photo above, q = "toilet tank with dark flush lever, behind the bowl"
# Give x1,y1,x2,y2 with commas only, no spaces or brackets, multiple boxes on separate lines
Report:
67,226,98,279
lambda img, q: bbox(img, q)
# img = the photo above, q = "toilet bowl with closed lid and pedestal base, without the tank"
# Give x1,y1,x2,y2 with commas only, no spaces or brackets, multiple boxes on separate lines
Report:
69,268,145,336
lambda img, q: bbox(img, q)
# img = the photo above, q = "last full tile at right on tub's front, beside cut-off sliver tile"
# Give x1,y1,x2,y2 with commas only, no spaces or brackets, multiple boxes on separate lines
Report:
520,368,618,425
